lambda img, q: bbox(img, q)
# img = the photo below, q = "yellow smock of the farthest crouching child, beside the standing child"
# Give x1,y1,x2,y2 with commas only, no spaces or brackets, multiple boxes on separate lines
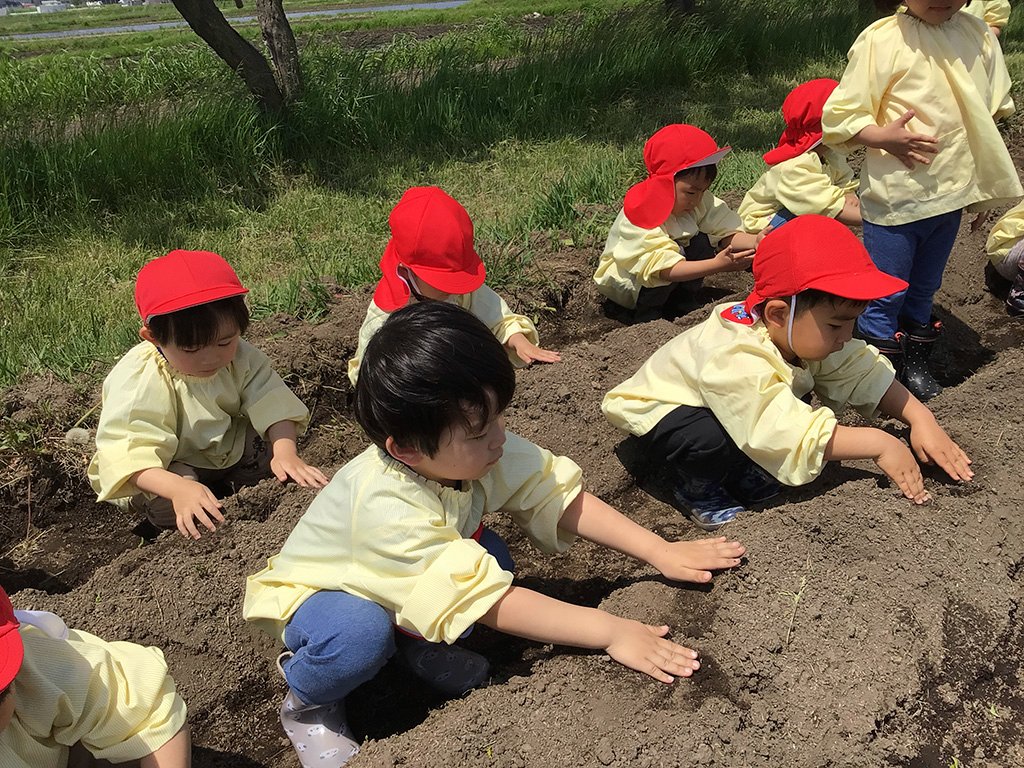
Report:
737,147,857,232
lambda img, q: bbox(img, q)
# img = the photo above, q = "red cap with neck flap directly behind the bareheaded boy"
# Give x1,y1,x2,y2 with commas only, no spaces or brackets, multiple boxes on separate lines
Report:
374,186,486,312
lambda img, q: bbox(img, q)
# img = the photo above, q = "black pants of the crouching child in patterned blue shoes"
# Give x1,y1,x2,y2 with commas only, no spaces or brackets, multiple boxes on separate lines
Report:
641,406,754,480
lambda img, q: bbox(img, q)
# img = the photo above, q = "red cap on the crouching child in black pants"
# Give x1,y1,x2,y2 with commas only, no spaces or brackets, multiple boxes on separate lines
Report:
743,213,907,323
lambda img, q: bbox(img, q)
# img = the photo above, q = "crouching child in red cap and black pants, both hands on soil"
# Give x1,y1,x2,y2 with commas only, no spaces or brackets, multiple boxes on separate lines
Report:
601,214,974,530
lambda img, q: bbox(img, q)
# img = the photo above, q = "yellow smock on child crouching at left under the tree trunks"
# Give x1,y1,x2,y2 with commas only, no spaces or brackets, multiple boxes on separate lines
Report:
89,339,309,502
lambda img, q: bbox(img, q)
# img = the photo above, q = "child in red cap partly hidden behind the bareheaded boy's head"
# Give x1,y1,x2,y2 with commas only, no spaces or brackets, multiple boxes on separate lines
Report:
348,186,561,387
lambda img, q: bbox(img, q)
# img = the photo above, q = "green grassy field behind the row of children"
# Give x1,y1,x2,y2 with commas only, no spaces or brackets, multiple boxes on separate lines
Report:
0,0,1024,385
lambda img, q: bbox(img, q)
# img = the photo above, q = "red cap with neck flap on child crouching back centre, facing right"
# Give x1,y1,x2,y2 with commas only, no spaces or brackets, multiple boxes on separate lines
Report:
624,123,732,229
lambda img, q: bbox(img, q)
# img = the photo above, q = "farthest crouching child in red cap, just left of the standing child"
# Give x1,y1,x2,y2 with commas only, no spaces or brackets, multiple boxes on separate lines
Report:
739,78,860,232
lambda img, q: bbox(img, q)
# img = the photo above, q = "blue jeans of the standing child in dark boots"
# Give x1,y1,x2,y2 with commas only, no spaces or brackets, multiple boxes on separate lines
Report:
857,211,963,339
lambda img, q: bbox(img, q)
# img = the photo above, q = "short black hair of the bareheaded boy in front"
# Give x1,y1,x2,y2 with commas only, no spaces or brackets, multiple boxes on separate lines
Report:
354,301,515,456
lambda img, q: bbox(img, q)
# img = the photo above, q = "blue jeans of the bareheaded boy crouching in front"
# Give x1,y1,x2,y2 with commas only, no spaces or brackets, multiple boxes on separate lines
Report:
284,528,515,705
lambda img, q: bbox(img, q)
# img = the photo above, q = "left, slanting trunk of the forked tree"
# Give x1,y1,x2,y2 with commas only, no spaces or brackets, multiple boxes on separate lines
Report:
172,0,284,112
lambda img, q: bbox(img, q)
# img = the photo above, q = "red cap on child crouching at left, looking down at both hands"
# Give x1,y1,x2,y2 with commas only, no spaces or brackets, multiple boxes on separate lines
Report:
135,251,249,323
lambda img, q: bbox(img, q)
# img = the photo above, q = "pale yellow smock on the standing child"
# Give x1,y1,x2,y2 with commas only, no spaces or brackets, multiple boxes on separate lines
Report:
821,13,1024,226
